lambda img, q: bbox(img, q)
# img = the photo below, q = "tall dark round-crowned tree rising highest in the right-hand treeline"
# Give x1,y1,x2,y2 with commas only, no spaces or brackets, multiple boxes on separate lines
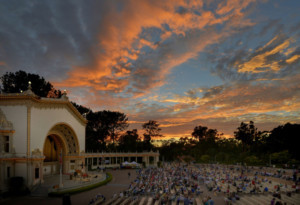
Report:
234,121,258,151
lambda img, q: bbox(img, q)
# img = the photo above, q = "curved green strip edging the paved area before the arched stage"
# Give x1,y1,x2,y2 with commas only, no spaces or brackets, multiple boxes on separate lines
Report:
48,173,112,197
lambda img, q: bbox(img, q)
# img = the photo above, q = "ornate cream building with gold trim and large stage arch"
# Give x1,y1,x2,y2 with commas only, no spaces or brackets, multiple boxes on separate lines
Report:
0,88,86,191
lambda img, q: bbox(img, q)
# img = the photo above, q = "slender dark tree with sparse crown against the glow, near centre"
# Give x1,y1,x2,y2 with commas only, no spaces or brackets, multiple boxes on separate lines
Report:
142,120,162,150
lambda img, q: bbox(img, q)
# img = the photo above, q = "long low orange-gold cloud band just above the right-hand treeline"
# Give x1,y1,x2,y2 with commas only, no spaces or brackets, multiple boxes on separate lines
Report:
128,74,300,137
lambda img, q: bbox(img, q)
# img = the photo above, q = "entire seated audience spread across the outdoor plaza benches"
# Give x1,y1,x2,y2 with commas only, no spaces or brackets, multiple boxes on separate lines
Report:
88,163,299,205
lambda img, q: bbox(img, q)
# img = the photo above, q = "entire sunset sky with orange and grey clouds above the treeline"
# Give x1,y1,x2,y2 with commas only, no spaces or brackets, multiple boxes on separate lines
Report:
0,0,300,139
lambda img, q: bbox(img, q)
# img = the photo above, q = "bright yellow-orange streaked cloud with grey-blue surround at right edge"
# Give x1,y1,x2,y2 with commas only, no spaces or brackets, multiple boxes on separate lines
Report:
206,23,300,82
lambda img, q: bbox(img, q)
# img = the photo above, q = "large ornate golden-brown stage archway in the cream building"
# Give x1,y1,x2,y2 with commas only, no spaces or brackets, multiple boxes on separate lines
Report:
43,123,80,175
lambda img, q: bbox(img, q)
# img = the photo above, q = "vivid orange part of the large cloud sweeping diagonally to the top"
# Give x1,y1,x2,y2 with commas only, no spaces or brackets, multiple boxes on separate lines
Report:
54,0,253,96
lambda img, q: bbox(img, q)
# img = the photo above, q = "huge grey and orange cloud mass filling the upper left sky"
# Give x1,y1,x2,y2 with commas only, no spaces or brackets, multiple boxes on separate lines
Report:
0,0,254,101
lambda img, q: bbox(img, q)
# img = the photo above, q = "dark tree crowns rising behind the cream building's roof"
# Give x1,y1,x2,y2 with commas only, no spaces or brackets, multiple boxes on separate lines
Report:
1,70,61,98
